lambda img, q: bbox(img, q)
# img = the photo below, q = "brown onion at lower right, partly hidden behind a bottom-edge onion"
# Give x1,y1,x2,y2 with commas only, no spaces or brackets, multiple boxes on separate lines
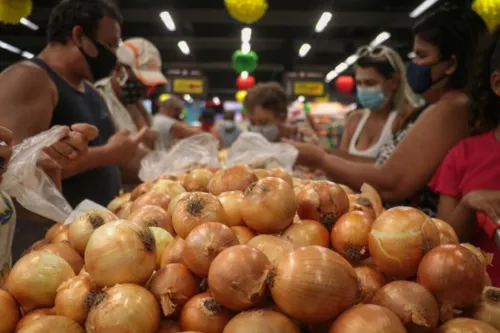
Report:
371,281,439,333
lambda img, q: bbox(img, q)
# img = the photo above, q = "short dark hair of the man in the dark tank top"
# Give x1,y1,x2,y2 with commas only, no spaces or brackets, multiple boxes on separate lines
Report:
47,0,122,44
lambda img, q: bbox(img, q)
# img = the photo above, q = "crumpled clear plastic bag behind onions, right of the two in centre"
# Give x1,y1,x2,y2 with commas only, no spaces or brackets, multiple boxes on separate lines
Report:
226,132,299,171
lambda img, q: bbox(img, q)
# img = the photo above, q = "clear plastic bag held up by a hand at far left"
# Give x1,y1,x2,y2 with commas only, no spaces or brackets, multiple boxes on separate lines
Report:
0,126,72,222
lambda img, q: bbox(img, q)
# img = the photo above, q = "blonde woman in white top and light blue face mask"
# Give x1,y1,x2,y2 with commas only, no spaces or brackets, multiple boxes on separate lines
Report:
334,46,417,162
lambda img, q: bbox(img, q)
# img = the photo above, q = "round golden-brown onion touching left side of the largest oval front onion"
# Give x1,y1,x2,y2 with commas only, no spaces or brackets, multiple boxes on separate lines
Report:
208,245,271,311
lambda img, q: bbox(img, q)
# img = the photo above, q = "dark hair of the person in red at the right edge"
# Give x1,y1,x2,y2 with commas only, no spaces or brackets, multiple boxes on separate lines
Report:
468,27,500,132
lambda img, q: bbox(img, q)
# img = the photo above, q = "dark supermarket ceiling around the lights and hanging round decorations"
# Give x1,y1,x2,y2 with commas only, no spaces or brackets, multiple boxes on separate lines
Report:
0,0,472,98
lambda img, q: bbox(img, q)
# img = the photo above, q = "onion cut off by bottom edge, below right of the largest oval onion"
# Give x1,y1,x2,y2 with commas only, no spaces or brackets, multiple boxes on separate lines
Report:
330,304,406,333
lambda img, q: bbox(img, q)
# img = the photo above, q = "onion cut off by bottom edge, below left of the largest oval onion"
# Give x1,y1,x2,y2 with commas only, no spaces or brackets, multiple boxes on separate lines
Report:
224,309,300,333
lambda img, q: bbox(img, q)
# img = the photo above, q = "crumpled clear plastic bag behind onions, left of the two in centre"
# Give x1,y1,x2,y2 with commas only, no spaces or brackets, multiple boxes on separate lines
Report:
139,133,220,182
